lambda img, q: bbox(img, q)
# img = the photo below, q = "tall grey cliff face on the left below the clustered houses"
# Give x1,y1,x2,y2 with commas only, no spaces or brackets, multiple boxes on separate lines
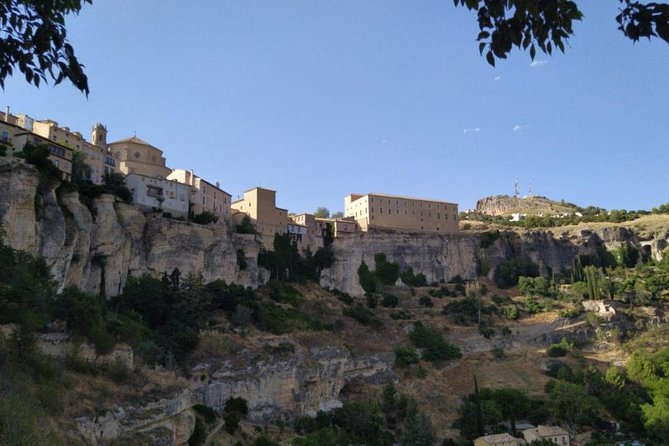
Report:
0,158,267,296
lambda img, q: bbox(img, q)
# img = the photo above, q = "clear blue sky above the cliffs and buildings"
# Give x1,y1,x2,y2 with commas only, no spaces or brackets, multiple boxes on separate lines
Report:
0,0,669,212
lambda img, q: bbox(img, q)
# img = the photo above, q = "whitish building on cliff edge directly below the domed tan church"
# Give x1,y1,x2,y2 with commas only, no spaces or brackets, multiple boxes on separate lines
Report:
125,173,190,218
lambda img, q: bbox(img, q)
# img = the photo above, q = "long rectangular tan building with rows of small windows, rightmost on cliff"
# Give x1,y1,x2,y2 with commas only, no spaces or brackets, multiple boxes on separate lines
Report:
344,194,458,234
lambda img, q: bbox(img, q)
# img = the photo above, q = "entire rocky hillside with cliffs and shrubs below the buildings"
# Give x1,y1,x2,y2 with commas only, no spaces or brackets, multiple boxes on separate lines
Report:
0,163,669,446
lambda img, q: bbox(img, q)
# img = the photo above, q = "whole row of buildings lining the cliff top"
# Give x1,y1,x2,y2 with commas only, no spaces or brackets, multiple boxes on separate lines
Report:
0,108,458,252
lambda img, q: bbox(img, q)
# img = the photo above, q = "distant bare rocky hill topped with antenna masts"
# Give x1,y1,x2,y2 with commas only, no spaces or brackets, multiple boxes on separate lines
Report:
476,195,580,215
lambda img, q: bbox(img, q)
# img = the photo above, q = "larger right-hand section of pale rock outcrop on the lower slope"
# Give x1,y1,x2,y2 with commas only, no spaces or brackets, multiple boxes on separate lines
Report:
193,346,394,423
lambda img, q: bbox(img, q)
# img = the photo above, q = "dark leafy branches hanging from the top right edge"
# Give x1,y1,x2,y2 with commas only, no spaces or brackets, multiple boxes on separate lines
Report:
454,0,669,66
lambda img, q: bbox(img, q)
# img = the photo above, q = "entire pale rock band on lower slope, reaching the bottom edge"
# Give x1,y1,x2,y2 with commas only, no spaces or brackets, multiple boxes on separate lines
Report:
76,345,395,445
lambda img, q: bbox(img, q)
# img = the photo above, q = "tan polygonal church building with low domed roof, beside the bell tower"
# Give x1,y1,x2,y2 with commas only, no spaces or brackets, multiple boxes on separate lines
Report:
109,136,172,178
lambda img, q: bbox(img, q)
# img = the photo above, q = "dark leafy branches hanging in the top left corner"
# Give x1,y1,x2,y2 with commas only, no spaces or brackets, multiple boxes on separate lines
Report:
0,0,92,96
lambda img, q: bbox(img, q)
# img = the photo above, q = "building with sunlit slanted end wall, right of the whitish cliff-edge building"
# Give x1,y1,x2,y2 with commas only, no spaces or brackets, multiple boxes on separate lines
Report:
167,169,232,220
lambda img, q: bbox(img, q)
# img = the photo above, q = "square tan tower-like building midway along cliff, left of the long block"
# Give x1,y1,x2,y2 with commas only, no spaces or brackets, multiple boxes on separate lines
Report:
231,187,288,249
